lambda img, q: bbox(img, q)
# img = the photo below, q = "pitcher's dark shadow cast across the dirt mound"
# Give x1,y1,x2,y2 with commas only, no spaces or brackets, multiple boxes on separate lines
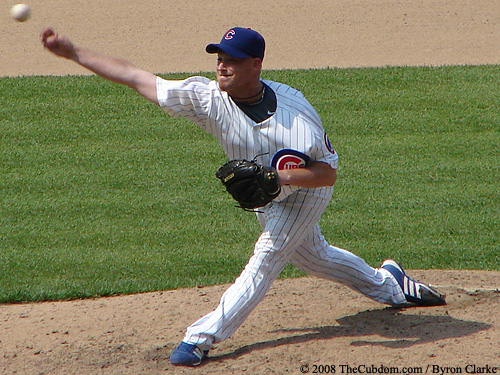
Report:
209,307,491,361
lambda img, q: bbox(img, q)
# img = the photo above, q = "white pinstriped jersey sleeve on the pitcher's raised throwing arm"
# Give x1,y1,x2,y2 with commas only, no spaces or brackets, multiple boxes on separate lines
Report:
156,77,214,126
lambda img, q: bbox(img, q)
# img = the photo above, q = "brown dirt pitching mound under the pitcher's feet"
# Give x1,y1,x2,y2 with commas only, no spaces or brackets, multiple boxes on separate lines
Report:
0,271,500,375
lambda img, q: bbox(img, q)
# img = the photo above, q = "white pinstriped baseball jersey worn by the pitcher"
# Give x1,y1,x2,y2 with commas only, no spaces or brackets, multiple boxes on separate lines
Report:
157,76,338,201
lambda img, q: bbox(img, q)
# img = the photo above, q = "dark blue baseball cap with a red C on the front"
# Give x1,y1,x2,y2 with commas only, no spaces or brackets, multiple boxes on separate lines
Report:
205,27,266,59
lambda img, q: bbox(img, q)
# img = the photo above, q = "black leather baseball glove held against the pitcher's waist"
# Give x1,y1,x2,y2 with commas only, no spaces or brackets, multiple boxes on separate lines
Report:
215,159,281,210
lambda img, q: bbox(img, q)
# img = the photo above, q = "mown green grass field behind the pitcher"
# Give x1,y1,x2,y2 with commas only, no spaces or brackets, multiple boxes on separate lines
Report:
0,66,500,303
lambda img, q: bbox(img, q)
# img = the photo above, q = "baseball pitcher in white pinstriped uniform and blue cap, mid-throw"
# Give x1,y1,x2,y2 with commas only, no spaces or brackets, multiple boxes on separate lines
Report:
41,27,445,366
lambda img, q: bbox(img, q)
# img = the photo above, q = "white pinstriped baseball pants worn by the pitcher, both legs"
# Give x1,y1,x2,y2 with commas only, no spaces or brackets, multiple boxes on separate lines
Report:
183,187,406,350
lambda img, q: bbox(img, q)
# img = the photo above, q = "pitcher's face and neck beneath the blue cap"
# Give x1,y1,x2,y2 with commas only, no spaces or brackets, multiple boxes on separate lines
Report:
217,52,262,98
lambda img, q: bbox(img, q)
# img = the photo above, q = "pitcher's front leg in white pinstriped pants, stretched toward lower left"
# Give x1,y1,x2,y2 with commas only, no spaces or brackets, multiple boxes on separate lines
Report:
174,193,327,364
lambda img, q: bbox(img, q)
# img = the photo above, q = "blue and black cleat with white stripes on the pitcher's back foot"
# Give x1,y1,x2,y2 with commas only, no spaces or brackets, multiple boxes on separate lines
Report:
382,259,446,306
